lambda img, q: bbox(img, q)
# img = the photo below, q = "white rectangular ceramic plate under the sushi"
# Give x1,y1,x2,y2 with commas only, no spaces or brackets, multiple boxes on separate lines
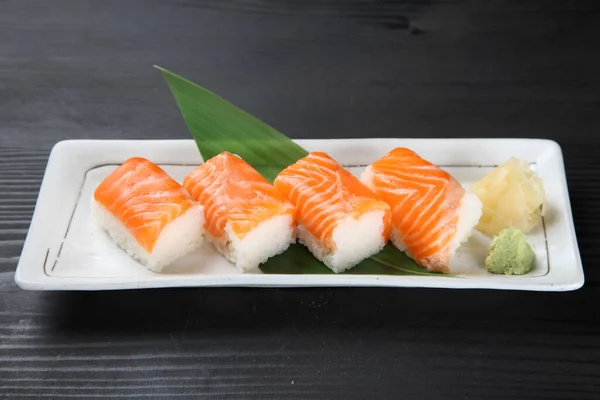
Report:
15,139,584,291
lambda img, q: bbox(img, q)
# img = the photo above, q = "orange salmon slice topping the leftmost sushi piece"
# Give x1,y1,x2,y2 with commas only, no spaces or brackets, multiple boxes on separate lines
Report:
94,157,196,253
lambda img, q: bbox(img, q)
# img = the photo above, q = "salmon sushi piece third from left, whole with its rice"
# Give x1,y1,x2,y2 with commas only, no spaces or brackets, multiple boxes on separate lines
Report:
274,152,391,273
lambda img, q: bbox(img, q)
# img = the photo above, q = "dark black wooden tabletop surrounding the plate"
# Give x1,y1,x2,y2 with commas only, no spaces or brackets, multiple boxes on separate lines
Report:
0,0,600,400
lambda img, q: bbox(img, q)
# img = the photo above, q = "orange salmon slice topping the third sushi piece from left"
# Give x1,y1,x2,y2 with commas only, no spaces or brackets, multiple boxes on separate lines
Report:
274,152,390,248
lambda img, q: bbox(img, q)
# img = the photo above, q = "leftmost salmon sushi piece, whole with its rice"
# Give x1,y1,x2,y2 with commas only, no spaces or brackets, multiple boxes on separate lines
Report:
92,157,204,272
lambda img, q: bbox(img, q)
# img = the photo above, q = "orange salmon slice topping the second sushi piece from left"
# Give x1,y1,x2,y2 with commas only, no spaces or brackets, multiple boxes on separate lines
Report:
183,152,296,239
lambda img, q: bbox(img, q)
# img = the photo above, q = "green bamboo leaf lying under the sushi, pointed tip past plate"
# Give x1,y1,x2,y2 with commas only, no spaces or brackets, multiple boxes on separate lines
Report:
156,66,450,276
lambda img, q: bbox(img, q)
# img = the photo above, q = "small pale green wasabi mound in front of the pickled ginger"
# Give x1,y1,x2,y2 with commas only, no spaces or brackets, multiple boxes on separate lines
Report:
485,228,535,275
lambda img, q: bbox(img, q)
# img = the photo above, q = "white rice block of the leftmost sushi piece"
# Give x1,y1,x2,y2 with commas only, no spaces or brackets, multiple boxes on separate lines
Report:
91,199,204,273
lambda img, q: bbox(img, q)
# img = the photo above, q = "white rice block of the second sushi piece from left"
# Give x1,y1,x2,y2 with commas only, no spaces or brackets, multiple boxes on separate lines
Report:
207,215,296,272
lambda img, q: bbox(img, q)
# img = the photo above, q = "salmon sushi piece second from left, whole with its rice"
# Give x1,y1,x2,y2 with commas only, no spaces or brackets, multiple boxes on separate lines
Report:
183,152,296,272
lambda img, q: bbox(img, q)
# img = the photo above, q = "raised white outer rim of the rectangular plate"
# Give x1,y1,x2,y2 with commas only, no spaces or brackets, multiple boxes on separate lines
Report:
14,137,585,291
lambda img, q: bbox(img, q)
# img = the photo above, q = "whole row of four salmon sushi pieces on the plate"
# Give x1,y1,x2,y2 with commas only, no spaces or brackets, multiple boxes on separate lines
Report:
92,148,482,273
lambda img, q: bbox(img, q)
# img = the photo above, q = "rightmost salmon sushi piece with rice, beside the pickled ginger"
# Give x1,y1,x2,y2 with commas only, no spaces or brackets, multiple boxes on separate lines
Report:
361,147,482,273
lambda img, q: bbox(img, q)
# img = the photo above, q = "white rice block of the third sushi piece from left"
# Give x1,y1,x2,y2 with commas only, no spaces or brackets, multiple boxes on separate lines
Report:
298,210,385,274
